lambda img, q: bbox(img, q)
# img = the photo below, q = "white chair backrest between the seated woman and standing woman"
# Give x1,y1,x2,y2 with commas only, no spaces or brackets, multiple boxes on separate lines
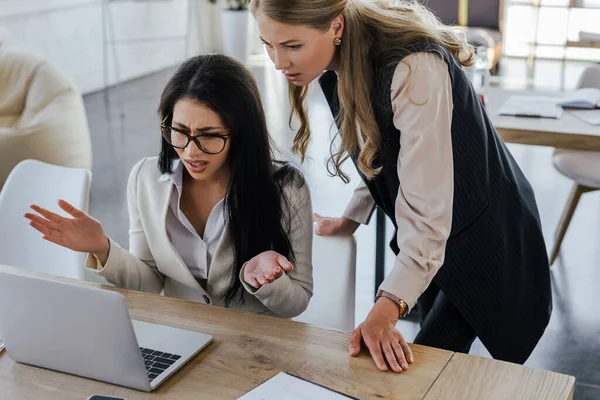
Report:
294,235,356,332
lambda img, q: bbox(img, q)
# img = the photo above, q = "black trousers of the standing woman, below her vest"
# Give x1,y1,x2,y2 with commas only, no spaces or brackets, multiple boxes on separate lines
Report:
414,282,477,353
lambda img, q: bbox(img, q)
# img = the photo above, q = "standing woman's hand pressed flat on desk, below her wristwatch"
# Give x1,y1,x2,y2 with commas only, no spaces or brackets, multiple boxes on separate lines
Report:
349,297,414,372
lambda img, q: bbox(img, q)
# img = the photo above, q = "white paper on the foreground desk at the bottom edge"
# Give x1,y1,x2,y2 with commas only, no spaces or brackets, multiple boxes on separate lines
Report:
237,372,352,400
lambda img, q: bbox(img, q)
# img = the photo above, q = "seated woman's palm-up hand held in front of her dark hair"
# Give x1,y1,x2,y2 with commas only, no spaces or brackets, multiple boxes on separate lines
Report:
244,250,294,289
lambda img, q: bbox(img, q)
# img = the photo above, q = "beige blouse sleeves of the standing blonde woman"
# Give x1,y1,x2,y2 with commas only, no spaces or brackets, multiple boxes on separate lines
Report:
344,53,454,308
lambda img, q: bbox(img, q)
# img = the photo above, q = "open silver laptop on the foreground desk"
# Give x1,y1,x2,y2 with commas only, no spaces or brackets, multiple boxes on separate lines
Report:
0,272,212,392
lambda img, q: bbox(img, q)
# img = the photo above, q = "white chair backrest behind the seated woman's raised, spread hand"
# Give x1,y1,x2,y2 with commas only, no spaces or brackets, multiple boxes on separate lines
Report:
0,160,91,279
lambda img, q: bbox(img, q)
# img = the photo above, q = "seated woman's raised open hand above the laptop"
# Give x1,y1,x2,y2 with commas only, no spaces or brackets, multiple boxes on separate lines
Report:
24,200,109,265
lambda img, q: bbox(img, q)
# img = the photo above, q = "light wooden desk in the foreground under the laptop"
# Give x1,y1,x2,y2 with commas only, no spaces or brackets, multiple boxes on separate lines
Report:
0,265,574,400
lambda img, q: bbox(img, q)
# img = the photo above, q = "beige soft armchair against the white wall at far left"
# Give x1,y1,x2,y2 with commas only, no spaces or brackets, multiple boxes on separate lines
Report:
0,44,92,188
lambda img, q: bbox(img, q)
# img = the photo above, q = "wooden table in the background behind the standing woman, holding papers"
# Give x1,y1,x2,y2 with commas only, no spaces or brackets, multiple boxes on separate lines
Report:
487,88,600,151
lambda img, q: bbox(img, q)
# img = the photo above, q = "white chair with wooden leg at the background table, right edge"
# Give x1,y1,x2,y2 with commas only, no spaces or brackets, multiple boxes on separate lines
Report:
550,65,600,265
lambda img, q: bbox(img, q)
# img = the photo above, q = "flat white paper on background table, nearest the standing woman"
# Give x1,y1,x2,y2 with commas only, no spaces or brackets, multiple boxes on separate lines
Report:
498,96,563,119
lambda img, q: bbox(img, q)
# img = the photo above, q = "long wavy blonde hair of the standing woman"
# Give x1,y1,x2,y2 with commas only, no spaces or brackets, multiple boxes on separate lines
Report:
250,0,473,182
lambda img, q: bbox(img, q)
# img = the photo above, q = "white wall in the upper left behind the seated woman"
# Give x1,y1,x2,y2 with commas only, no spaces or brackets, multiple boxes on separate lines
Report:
0,0,221,93
